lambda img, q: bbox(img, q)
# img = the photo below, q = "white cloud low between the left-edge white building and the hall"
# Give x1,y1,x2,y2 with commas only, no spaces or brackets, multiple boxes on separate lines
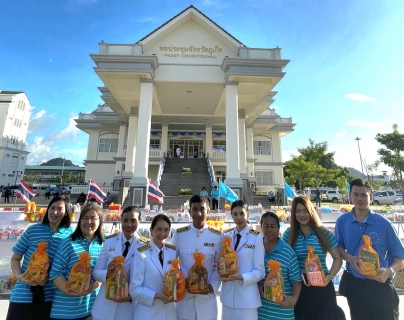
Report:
27,113,88,165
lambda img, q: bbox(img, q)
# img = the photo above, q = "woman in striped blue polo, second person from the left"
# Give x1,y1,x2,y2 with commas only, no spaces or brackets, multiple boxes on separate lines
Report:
49,203,104,320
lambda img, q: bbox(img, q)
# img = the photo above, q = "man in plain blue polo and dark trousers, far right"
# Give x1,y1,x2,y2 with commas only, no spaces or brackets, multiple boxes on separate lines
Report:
335,179,404,320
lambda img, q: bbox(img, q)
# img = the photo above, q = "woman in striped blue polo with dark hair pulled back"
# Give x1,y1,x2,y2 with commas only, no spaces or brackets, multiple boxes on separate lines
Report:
258,212,302,320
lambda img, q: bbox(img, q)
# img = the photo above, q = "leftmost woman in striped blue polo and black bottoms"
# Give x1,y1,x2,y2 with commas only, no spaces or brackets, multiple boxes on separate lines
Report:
6,196,73,320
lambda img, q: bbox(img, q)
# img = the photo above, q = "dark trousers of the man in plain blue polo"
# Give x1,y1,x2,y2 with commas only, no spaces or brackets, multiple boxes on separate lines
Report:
346,274,400,320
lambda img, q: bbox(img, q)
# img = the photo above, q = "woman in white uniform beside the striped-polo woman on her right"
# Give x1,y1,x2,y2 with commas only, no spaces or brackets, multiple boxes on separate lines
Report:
220,200,265,320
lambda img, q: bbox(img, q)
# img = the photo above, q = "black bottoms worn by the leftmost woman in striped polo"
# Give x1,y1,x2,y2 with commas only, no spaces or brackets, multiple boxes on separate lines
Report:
6,301,52,320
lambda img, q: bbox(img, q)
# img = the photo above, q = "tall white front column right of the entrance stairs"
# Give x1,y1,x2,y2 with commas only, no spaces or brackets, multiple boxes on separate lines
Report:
226,82,243,187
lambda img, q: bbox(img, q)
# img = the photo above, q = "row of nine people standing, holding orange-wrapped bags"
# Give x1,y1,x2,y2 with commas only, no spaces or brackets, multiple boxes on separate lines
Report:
7,179,404,320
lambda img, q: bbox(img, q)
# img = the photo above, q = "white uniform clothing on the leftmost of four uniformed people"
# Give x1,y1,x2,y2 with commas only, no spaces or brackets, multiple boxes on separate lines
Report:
91,233,150,320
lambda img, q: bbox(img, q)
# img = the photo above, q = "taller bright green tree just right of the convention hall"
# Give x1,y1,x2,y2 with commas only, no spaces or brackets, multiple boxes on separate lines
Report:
297,139,337,186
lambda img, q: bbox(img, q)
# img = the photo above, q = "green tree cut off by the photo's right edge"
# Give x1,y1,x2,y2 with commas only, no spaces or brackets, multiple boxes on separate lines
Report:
375,124,404,204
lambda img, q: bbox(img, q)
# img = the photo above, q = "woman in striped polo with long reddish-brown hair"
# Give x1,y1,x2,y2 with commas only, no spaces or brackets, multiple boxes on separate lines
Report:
283,196,345,320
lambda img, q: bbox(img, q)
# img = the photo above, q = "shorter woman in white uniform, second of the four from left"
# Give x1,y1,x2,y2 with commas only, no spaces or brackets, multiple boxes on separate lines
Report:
129,214,177,320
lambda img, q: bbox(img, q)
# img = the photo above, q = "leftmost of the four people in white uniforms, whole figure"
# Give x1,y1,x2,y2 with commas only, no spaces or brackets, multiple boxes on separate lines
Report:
91,206,150,320
